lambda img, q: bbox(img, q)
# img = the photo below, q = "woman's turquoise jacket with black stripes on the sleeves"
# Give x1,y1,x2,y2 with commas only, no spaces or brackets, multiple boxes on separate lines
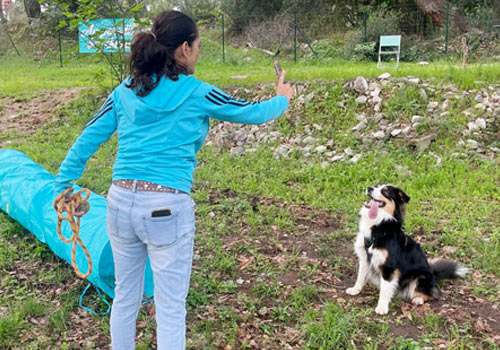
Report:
54,75,288,195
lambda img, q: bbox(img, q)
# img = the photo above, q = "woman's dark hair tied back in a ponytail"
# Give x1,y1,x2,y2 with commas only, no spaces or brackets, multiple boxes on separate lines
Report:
125,10,198,96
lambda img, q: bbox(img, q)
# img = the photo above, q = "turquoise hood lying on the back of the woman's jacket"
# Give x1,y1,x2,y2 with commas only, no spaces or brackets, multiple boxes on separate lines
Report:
115,75,202,125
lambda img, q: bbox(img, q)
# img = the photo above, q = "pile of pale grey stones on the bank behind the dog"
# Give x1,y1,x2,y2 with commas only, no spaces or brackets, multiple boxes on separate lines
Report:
207,73,500,166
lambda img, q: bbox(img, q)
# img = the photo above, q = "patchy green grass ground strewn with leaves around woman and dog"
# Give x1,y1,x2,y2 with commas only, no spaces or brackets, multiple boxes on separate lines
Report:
0,44,500,350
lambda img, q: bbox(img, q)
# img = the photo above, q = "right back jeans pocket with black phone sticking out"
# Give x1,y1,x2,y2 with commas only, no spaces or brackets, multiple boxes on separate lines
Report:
143,213,177,247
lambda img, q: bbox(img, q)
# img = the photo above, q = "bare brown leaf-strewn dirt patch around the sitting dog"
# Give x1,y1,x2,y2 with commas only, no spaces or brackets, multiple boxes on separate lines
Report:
200,190,500,348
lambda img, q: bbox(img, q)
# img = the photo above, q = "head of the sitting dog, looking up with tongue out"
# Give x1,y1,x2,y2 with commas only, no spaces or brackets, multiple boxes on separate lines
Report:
360,184,410,223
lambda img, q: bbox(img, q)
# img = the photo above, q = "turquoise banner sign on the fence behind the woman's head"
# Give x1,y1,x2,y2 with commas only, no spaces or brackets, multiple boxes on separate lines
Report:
78,18,134,53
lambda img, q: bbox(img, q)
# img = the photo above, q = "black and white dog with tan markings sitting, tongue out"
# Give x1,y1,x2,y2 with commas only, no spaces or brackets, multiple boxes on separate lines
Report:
347,185,469,315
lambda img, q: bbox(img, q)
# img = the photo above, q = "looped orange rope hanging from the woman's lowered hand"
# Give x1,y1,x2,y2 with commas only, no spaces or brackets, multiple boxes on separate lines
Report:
54,188,92,279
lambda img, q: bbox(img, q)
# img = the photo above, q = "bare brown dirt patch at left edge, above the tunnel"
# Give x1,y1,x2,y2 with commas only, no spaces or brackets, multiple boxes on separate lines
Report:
0,87,83,147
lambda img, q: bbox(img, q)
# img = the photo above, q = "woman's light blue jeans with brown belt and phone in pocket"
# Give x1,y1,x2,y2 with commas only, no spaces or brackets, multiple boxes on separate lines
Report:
106,185,195,350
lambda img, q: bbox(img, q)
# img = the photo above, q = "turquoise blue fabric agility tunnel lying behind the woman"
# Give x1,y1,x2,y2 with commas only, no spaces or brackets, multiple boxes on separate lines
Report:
0,149,153,298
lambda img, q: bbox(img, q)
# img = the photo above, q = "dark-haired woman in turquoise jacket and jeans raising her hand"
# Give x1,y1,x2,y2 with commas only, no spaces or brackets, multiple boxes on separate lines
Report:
55,11,293,350
